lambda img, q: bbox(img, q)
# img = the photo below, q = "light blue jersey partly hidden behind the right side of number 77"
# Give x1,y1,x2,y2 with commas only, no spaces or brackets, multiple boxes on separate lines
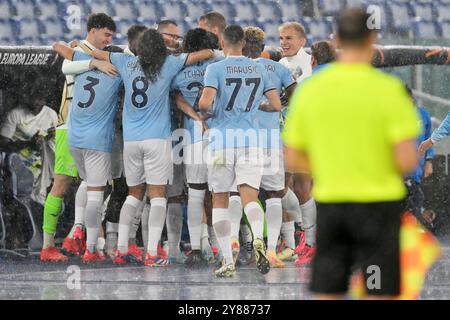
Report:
255,58,296,149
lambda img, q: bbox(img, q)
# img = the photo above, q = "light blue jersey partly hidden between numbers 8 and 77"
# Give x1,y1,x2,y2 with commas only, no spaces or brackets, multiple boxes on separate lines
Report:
172,57,224,144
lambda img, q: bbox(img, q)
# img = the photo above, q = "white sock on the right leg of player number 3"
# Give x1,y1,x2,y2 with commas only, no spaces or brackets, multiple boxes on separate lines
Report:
85,191,103,253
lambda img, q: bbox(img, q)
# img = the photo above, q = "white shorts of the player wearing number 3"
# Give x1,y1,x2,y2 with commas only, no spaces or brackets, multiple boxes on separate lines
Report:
70,147,111,187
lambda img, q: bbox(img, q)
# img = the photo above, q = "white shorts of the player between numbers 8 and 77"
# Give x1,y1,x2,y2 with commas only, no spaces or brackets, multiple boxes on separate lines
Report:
183,140,208,183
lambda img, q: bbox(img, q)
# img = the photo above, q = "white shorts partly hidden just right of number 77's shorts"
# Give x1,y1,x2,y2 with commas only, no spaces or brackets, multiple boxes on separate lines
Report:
261,149,285,191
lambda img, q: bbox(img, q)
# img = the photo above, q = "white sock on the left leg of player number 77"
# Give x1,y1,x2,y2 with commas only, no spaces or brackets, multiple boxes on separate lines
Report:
212,208,234,265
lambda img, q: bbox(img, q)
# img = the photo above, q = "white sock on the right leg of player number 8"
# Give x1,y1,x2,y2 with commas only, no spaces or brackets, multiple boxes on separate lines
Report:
147,198,167,256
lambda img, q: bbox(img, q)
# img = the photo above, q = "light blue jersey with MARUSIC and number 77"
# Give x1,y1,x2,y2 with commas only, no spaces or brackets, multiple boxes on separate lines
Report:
205,56,275,150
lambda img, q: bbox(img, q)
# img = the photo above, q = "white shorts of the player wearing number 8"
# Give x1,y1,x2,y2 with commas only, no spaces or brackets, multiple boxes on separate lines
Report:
123,139,173,187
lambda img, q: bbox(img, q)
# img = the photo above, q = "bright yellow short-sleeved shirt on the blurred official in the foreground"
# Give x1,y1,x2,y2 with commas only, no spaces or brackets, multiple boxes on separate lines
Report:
283,62,420,203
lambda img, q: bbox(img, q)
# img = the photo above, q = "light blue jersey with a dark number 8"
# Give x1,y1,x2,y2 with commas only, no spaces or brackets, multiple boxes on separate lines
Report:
110,53,187,141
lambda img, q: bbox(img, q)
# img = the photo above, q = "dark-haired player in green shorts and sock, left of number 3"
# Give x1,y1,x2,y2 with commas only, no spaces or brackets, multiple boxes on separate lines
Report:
40,13,116,261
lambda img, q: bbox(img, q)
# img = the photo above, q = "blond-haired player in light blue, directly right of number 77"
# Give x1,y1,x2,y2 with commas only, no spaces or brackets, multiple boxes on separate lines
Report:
241,27,296,268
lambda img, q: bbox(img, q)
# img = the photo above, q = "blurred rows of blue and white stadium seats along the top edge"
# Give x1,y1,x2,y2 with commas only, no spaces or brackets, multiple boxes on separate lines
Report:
0,0,450,45
